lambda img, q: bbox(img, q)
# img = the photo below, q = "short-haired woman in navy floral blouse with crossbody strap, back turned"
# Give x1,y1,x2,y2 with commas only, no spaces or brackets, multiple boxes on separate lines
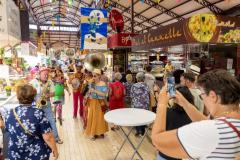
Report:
3,84,58,160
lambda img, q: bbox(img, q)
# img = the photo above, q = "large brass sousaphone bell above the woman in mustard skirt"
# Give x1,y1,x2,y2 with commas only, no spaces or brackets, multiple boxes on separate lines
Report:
84,53,105,72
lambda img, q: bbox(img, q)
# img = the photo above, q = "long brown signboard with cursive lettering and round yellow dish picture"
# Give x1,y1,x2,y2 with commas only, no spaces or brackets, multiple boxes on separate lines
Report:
132,14,240,51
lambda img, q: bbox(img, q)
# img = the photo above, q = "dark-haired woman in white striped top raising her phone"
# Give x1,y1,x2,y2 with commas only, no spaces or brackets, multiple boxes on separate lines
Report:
152,70,240,159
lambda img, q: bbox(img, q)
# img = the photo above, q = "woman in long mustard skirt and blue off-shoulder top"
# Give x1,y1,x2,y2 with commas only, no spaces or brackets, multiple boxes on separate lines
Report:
85,69,108,140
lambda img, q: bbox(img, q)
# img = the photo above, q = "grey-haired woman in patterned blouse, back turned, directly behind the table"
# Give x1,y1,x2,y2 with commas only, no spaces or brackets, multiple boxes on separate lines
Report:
130,72,150,137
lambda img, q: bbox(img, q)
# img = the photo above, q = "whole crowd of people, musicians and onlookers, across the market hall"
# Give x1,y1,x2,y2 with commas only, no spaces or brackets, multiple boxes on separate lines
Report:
0,60,240,160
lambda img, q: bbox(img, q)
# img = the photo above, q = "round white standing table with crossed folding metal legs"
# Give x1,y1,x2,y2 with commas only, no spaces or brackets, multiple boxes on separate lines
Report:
104,108,156,160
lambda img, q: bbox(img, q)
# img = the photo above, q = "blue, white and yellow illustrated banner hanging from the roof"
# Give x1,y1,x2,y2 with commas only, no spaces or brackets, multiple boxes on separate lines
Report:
81,8,108,50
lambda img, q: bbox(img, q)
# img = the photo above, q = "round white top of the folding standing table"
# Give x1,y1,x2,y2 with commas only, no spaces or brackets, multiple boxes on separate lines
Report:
104,108,156,127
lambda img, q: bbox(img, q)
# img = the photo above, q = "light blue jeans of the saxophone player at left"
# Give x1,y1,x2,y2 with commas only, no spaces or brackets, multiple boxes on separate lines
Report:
43,102,59,141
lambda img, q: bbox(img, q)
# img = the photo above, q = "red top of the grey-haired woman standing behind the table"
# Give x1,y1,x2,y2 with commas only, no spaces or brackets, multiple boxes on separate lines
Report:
109,82,125,110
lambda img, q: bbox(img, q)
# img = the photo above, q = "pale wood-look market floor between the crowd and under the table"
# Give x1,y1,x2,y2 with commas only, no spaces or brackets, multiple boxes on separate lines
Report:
50,95,156,160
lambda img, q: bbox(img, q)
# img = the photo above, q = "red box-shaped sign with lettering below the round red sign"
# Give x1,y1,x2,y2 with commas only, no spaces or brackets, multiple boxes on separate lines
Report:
108,33,136,48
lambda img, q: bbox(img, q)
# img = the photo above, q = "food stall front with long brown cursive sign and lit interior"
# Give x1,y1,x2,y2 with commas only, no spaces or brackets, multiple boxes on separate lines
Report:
132,14,240,75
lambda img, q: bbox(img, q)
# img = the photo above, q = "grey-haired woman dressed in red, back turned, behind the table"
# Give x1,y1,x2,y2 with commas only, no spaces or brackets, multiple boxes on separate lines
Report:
109,72,125,130
